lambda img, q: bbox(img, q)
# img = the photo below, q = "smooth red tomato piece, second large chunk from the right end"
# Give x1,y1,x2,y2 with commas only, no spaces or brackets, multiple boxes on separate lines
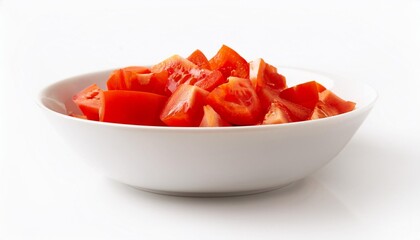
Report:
279,81,325,110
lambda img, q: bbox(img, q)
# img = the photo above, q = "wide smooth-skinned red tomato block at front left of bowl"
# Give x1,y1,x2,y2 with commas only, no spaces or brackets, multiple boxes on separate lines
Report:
99,90,167,126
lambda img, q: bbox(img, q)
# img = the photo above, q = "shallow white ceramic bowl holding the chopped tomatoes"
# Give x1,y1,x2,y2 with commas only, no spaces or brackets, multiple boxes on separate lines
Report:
38,68,377,196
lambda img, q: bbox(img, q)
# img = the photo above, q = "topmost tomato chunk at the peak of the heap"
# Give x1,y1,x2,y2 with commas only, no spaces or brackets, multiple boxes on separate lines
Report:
209,45,249,78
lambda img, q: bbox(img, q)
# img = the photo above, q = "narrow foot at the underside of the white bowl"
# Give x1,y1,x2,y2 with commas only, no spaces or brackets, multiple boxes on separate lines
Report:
132,182,295,198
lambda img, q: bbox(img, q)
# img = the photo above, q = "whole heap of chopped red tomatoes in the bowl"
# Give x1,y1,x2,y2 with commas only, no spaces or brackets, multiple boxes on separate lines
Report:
71,45,356,127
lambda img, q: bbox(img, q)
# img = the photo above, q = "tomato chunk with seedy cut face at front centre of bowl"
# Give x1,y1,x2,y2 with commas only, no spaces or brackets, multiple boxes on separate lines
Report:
207,77,262,125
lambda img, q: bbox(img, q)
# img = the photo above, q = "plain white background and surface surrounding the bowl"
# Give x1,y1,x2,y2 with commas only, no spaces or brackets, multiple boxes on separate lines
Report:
0,0,420,239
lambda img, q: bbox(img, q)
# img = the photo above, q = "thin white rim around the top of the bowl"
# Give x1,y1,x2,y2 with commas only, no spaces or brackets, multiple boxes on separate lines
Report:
36,66,379,133
